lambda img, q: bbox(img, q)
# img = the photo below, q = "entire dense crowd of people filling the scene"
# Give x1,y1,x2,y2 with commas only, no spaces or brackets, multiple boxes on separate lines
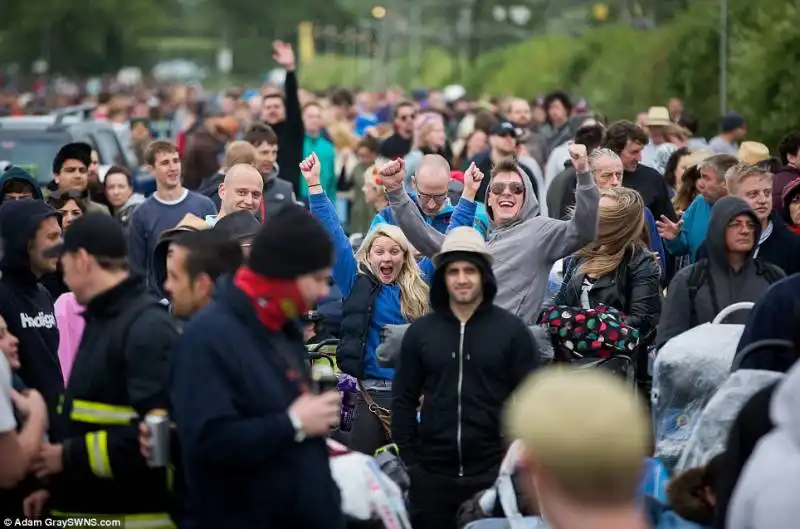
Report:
0,42,800,529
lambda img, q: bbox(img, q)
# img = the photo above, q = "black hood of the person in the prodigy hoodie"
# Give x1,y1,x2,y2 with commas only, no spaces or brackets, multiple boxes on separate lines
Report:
0,200,60,275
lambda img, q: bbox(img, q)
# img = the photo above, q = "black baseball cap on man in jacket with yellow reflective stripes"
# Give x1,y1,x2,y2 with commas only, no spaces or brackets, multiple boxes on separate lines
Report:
44,213,128,259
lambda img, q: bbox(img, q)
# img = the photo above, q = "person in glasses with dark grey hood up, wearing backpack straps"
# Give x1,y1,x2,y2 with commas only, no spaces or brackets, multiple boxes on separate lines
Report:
656,196,785,347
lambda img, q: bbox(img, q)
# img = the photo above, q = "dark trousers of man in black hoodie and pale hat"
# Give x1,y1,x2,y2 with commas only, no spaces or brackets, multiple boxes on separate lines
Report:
409,465,497,529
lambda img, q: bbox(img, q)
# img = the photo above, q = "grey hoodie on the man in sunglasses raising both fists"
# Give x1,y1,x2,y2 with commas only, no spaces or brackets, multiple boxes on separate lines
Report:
388,173,600,325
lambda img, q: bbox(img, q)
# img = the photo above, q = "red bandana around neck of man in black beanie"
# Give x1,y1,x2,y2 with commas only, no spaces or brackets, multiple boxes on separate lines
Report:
233,266,308,332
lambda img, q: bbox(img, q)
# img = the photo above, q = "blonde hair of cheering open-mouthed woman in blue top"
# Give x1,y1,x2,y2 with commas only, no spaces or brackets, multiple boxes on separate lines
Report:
356,224,430,321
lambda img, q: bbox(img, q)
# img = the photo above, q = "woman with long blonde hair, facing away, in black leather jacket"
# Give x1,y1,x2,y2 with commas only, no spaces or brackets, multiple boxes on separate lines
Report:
553,187,661,336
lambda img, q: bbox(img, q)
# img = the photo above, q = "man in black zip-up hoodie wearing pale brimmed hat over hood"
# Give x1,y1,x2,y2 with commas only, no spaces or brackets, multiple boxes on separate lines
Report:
392,227,539,529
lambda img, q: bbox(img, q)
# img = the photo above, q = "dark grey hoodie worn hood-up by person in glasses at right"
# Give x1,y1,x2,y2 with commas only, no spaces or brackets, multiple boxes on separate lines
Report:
656,196,784,347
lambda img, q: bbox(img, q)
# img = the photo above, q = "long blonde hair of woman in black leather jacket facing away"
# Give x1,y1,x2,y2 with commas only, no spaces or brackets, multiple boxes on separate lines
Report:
577,187,647,277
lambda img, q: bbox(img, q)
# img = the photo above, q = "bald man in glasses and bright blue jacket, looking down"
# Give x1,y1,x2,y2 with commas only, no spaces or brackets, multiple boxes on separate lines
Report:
369,154,489,237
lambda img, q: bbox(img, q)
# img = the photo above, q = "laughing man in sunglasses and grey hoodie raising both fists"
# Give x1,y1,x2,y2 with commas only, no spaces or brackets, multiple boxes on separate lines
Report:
381,144,600,325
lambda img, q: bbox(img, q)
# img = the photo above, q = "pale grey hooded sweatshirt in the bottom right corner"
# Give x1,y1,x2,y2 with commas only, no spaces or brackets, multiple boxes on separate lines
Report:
727,363,800,529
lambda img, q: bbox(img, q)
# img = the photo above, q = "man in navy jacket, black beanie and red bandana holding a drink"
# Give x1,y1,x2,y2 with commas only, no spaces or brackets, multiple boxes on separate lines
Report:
171,206,344,529
